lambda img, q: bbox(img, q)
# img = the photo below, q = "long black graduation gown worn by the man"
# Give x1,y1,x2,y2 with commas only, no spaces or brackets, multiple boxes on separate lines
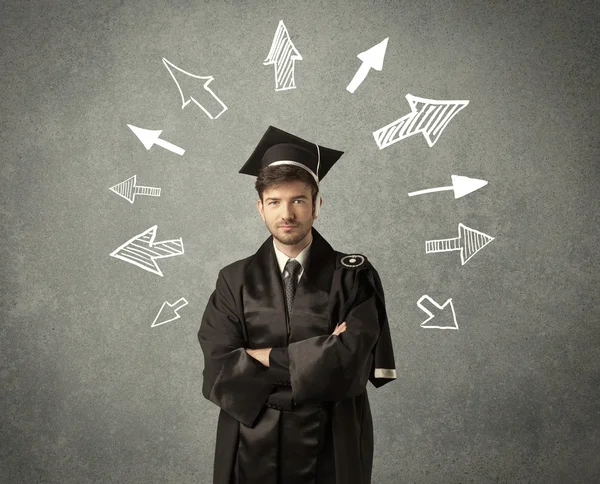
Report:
198,227,396,484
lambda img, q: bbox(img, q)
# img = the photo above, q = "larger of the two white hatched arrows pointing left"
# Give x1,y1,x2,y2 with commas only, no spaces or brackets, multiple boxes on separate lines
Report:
110,225,183,277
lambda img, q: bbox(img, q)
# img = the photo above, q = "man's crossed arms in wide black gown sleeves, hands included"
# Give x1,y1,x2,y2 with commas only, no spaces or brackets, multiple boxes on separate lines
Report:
198,271,379,427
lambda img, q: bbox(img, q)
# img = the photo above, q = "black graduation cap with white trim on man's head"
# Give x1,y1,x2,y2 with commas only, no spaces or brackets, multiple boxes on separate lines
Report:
239,126,344,186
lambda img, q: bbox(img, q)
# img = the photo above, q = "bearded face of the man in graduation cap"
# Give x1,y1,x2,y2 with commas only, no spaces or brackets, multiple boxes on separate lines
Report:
258,181,316,245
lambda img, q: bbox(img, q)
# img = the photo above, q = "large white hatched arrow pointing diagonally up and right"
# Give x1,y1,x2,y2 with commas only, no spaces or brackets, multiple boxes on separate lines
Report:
373,94,469,150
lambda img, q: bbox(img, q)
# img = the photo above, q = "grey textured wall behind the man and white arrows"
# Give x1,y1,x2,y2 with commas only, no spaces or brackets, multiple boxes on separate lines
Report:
0,0,600,484
